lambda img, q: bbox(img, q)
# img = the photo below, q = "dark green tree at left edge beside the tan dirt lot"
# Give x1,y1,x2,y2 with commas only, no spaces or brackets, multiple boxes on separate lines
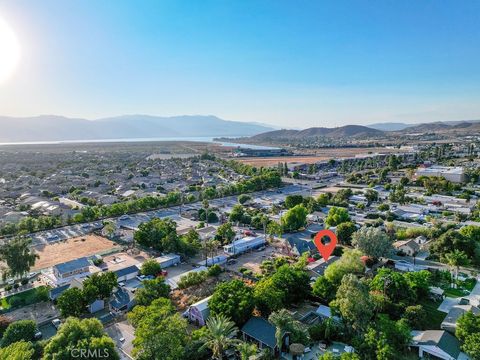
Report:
0,237,38,279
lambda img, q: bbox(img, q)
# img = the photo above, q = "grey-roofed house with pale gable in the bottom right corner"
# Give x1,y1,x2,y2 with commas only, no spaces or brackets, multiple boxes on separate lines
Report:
410,330,469,360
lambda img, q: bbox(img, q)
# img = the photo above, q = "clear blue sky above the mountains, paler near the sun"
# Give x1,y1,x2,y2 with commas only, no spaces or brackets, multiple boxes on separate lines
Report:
0,0,480,127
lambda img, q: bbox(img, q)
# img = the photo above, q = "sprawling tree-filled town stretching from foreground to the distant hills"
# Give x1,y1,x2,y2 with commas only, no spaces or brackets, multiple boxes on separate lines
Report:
0,134,480,360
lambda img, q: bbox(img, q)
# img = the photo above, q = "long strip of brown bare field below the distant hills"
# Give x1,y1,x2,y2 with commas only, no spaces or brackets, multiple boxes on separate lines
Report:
236,147,406,166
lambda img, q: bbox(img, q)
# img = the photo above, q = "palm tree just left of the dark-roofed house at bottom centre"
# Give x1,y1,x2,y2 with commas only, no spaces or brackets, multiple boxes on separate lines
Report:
202,315,239,360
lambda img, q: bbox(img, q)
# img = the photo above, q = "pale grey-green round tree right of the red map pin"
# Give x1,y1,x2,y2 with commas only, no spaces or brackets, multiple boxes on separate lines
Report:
352,226,392,259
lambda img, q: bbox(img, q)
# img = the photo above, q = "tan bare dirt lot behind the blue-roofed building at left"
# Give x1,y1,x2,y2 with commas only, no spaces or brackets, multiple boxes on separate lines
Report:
33,235,120,270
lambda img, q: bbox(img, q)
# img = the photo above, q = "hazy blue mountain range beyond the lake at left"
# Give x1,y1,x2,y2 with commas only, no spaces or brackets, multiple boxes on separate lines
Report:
0,115,274,142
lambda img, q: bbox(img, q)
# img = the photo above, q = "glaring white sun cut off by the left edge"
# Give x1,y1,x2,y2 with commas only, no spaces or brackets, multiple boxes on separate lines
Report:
0,17,20,84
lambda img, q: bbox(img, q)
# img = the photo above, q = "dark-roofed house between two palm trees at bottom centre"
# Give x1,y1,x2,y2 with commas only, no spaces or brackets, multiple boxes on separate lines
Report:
241,316,290,354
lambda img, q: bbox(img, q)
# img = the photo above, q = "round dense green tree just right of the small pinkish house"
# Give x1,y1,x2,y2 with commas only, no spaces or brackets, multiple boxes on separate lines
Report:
208,280,255,326
